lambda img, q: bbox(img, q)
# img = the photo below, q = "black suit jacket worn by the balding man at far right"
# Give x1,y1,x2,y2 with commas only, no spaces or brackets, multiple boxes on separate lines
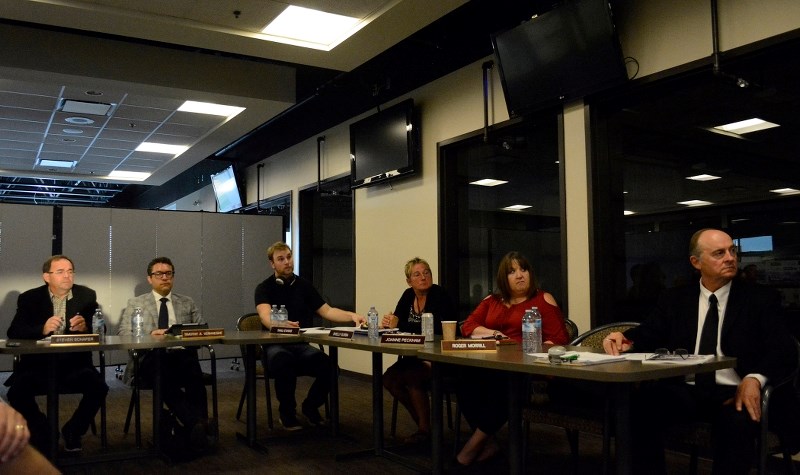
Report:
625,280,797,383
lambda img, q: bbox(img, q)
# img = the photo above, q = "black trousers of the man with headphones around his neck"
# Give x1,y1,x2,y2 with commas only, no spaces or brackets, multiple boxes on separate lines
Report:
264,343,331,418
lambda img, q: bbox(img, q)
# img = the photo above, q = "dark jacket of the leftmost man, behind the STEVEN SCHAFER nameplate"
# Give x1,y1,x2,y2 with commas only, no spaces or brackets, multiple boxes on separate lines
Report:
6,285,98,386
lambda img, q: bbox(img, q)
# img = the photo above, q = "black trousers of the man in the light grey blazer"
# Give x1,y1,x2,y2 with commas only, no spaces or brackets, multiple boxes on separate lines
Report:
139,349,208,428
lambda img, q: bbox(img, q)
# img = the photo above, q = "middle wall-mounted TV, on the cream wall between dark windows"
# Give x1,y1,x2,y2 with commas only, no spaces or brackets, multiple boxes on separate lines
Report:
350,99,419,188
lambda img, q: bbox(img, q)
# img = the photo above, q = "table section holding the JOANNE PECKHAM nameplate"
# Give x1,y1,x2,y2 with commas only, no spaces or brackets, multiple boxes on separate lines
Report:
303,334,424,469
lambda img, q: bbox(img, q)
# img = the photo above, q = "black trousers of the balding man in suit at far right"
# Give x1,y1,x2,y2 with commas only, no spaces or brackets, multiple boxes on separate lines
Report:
631,380,758,475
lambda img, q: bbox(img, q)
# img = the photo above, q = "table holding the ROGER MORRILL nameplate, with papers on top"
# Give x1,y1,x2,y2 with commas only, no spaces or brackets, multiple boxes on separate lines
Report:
417,345,736,473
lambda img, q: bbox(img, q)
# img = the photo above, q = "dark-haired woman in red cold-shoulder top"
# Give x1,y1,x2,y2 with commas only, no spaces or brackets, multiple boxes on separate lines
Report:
456,252,568,465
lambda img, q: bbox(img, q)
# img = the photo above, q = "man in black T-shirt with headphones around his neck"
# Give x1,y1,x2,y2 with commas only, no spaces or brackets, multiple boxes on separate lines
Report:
255,242,364,430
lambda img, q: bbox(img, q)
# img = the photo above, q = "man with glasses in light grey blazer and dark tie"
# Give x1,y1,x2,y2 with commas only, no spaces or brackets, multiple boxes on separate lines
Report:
118,257,208,453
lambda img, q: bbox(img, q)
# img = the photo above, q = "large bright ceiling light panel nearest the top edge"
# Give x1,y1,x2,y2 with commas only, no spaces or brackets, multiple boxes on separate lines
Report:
262,5,364,51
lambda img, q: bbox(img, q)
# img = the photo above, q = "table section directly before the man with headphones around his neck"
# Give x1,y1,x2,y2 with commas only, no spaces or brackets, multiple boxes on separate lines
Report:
222,331,303,453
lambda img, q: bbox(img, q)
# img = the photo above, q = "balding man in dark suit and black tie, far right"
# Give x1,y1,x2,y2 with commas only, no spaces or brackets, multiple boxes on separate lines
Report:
603,229,797,474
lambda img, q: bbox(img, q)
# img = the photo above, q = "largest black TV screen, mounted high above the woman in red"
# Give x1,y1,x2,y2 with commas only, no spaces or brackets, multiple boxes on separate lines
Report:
492,0,628,117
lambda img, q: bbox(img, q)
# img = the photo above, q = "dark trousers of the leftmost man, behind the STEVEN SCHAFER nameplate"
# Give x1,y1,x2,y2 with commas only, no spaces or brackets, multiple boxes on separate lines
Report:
8,365,108,451
